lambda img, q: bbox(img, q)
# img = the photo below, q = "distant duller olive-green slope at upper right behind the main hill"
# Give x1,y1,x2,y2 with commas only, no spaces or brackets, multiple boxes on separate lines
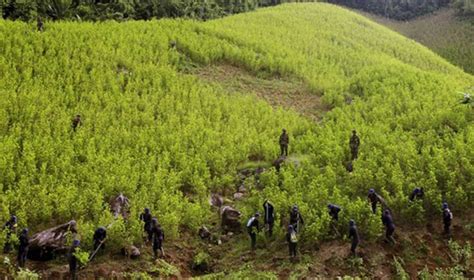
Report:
362,8,474,73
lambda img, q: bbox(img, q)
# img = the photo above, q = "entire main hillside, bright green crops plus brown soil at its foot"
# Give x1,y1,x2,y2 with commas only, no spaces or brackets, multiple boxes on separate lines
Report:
0,3,474,279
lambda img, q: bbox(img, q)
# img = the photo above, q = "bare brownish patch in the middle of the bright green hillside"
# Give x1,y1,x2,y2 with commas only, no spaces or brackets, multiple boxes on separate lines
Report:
193,64,329,121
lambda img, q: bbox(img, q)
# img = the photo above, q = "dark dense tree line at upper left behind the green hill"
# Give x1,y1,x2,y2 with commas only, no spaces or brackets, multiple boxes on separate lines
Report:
0,0,312,20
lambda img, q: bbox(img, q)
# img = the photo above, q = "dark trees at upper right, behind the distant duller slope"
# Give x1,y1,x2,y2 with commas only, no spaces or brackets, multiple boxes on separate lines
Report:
329,0,450,20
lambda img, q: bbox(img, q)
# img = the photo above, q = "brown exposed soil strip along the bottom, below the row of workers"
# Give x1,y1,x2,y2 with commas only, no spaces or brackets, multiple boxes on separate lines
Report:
0,202,474,279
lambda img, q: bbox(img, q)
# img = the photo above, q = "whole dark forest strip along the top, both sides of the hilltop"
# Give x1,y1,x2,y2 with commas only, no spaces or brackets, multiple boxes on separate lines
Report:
0,0,474,21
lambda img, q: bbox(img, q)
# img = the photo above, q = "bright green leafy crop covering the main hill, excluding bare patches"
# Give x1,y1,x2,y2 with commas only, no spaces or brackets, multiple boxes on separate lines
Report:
0,4,474,278
